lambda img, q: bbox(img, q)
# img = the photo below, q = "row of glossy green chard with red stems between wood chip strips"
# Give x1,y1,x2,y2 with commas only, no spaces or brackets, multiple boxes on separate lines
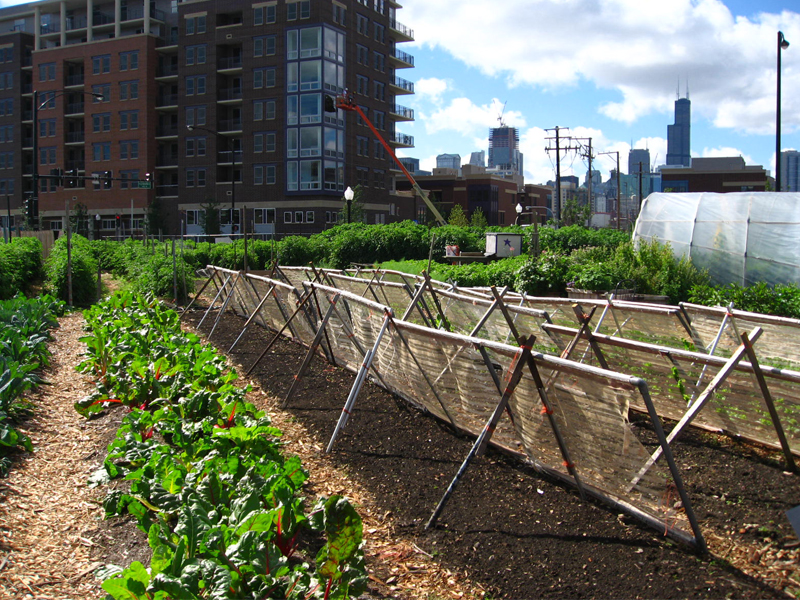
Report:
76,292,366,600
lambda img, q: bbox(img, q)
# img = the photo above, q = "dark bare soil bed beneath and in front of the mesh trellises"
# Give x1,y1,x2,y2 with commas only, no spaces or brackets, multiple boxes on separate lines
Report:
185,311,800,598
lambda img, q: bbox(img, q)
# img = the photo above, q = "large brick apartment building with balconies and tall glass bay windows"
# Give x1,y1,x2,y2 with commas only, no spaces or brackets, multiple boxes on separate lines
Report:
0,0,414,236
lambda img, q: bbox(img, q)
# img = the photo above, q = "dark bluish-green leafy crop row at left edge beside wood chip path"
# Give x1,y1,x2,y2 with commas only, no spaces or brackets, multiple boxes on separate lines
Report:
0,296,64,476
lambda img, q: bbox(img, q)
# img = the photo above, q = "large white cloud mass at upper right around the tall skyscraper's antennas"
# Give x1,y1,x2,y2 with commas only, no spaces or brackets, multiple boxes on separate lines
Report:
402,0,800,133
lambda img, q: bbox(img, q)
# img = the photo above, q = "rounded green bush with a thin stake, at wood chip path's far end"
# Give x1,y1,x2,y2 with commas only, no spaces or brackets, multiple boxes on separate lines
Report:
45,235,97,306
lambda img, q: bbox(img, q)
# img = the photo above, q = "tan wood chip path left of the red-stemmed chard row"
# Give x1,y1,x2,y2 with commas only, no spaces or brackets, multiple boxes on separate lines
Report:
0,313,104,600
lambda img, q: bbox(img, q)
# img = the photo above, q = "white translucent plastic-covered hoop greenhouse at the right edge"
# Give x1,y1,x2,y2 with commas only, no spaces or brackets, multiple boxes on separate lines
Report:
633,192,800,285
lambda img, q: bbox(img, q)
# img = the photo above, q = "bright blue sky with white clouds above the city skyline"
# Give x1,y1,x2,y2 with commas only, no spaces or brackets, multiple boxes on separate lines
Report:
397,0,800,183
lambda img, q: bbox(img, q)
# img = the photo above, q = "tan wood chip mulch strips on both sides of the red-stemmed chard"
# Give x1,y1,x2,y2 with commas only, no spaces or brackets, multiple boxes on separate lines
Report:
0,313,485,600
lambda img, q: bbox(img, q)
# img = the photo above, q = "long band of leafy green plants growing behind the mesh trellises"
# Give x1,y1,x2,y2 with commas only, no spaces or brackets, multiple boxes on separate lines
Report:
6,221,800,318
